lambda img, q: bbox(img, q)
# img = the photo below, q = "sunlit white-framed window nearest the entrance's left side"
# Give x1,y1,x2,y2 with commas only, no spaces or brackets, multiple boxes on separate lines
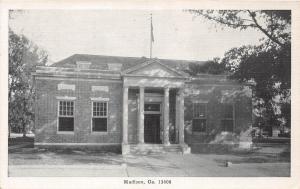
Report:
92,102,107,132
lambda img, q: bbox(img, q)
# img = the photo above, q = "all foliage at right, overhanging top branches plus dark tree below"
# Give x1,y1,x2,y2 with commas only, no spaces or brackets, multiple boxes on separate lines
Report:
188,10,291,129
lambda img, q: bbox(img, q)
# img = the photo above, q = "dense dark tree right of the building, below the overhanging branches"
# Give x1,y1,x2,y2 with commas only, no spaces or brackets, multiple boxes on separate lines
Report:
222,39,291,127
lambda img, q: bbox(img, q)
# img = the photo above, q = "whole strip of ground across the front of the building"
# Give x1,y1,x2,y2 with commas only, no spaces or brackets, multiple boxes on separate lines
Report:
9,148,290,177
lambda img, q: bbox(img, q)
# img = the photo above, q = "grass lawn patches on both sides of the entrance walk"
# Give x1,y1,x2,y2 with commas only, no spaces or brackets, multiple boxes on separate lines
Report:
8,134,290,165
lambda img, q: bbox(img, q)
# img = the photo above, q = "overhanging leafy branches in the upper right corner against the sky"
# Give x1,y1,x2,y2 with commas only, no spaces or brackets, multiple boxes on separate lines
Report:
188,10,291,47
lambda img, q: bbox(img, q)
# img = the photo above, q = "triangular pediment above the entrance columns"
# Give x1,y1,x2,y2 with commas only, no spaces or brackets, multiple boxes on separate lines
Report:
125,61,184,77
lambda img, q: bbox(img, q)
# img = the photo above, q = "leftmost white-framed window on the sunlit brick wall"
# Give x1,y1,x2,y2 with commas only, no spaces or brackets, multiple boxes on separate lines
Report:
58,101,74,131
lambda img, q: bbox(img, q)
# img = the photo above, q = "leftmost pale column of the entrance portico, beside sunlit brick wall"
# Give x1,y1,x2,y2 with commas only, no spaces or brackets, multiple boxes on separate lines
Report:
123,86,128,144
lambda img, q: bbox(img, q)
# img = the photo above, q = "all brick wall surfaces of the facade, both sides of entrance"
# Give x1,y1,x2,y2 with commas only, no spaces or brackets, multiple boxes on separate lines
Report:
35,76,252,147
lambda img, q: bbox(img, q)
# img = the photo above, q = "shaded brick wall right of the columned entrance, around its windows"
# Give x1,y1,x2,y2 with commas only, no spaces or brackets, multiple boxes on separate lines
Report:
185,82,252,144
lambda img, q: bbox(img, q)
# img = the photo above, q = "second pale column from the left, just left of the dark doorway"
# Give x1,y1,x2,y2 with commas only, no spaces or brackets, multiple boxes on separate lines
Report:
138,87,145,144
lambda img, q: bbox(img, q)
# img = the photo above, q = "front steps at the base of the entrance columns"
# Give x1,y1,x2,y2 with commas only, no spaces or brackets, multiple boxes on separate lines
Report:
129,144,182,154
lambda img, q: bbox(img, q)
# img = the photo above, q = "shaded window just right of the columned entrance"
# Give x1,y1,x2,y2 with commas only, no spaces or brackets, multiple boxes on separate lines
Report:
193,103,206,132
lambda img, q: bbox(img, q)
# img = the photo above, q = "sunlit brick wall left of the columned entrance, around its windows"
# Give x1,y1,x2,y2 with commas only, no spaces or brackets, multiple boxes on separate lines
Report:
35,78,122,143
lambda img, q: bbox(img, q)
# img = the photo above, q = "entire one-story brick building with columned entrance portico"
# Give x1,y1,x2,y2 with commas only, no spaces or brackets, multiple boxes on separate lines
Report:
33,54,252,154
